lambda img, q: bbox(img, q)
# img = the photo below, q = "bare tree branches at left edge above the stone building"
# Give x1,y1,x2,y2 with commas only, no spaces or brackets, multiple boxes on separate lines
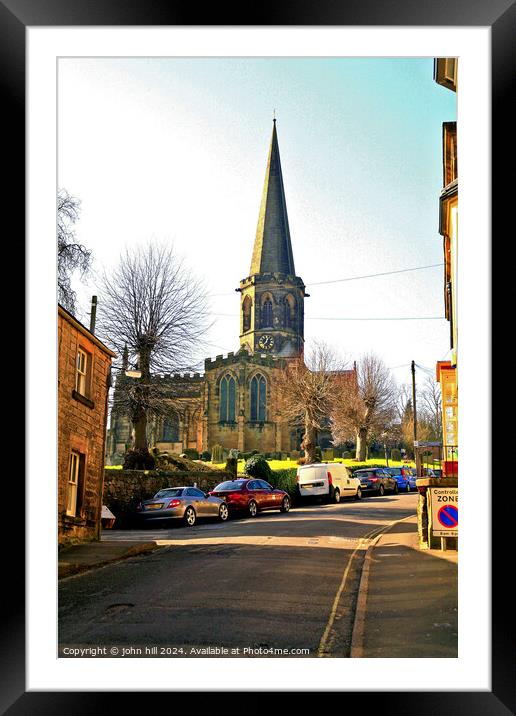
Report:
57,189,91,313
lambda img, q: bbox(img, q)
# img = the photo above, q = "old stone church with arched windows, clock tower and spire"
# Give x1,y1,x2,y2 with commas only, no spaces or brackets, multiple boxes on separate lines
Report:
107,119,308,464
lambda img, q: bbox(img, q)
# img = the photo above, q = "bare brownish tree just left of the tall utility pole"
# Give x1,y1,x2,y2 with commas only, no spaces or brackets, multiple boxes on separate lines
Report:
331,353,396,461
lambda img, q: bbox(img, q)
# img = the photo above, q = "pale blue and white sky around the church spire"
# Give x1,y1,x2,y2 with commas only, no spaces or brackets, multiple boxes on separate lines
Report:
58,58,456,392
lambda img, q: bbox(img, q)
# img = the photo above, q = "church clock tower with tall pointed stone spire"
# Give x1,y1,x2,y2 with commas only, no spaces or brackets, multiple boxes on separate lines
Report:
237,120,308,358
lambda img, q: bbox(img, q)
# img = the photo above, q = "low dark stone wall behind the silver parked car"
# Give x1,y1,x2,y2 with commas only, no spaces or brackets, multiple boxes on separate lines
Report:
103,470,233,528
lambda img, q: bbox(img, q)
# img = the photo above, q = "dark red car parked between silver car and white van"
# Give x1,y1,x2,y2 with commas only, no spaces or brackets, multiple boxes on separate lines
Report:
209,477,290,517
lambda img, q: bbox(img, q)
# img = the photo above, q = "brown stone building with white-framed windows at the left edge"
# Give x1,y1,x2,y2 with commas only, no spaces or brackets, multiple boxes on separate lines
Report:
58,306,116,543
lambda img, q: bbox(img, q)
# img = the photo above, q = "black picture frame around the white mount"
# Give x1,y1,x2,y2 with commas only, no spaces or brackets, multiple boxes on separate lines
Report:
7,0,508,716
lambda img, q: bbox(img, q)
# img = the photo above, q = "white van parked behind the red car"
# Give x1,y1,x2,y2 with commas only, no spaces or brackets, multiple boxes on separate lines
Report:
296,462,362,502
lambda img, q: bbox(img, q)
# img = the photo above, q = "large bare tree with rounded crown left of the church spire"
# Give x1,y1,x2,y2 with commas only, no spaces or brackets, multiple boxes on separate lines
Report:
98,243,208,450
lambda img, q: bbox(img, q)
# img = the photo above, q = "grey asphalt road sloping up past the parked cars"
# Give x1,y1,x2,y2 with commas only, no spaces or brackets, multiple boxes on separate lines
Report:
59,493,417,658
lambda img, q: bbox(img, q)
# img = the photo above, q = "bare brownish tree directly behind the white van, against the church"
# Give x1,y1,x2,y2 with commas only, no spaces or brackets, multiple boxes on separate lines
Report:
276,343,342,464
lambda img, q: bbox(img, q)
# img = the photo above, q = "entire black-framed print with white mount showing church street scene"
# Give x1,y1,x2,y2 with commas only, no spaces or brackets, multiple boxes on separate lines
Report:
4,0,510,714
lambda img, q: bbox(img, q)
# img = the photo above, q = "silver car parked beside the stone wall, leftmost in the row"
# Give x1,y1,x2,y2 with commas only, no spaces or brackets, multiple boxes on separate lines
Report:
136,487,229,527
